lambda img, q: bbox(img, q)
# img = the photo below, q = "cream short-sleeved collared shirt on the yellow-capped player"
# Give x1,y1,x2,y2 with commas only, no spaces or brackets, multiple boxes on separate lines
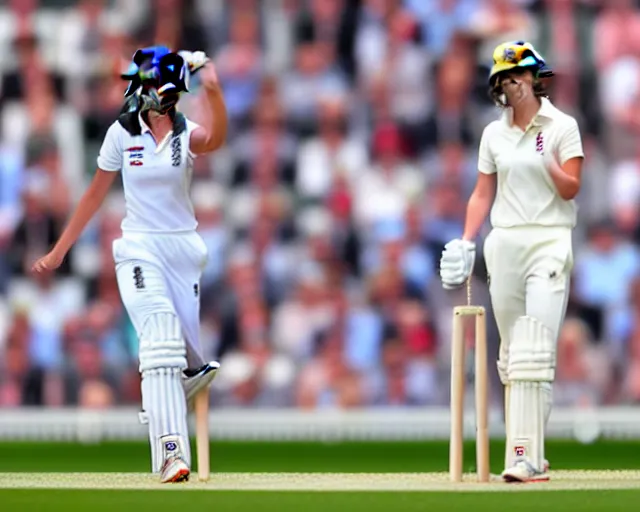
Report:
478,98,584,228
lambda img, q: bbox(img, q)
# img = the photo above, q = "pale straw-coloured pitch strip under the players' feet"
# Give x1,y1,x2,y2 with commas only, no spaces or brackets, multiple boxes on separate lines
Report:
0,471,640,491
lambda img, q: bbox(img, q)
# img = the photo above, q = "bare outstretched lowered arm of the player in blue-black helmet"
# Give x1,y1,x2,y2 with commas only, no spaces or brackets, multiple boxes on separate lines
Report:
32,169,118,272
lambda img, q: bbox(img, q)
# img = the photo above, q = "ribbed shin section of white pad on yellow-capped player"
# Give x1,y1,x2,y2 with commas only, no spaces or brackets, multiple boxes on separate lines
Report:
505,382,544,470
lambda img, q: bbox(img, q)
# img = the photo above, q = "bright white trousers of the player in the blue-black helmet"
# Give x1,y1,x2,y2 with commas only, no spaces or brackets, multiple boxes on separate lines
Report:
113,231,207,367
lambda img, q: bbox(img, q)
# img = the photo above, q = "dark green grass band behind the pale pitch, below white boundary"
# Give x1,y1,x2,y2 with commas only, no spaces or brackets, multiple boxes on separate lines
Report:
0,441,640,473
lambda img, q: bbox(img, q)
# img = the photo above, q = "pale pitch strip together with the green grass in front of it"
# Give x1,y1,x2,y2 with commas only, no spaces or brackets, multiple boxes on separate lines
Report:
0,471,640,512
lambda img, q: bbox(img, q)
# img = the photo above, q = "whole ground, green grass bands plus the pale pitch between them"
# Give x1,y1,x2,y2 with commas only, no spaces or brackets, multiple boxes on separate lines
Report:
0,441,640,512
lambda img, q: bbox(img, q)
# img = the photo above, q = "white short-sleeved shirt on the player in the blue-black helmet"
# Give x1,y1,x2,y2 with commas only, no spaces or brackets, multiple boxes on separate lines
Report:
98,114,198,233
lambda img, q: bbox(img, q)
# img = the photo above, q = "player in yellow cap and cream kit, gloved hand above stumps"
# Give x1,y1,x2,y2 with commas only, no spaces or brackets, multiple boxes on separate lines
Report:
440,41,584,482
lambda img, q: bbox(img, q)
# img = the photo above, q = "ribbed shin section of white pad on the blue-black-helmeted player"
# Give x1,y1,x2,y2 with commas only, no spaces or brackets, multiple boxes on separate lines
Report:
142,368,191,473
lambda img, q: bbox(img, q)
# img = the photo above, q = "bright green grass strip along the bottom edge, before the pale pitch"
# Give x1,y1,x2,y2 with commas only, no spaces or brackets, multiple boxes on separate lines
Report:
0,490,640,512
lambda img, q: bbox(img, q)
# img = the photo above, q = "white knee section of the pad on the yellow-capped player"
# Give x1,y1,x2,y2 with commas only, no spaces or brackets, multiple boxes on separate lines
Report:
508,316,556,382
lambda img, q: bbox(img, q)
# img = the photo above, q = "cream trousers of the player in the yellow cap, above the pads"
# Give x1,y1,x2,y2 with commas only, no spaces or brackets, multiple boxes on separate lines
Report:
484,227,573,357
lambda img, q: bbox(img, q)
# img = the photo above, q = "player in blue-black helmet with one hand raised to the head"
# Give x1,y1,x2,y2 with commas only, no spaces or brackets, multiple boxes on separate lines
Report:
33,46,227,482
